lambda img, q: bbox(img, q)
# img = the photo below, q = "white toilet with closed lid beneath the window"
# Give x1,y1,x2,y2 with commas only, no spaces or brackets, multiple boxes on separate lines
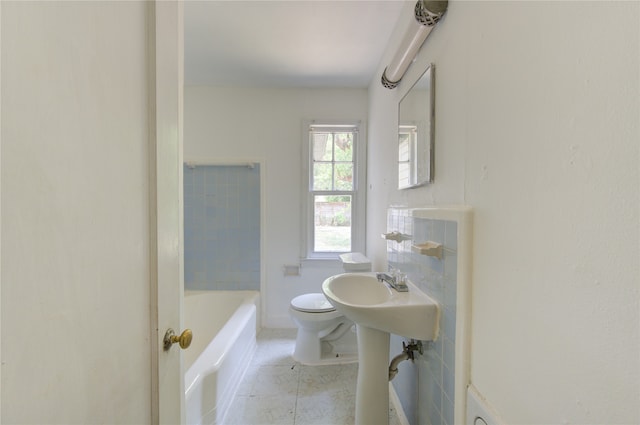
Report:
289,252,371,365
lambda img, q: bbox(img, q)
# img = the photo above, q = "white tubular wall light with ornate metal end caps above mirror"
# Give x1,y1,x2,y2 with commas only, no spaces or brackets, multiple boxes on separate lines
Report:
382,0,449,89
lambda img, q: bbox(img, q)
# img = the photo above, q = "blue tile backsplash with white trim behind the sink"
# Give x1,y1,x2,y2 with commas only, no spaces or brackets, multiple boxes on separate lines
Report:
387,208,458,425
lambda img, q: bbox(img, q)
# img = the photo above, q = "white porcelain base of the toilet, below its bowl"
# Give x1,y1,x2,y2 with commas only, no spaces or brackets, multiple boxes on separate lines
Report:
293,327,358,366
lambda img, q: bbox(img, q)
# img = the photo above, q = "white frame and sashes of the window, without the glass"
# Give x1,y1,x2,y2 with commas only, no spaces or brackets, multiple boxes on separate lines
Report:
301,120,366,260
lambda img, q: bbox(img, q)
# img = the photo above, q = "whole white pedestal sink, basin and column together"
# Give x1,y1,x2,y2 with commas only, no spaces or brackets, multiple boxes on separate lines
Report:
322,273,440,425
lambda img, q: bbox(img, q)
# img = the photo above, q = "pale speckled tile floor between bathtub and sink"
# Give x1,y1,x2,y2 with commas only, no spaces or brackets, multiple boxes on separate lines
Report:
224,329,400,425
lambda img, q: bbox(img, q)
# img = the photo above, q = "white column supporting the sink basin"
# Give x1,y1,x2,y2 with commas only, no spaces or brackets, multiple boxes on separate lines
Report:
356,325,389,425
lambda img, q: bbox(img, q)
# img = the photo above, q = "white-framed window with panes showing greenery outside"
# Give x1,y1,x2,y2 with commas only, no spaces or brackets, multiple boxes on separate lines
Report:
305,124,364,259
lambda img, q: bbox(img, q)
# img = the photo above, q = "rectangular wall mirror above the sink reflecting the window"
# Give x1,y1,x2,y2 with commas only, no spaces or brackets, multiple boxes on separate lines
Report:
398,64,435,189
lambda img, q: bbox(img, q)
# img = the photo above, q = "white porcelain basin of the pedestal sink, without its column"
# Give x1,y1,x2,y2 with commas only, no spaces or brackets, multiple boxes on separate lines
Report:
322,273,440,341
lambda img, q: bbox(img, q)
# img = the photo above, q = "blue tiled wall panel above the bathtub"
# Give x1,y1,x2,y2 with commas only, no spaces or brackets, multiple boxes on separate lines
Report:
184,164,260,290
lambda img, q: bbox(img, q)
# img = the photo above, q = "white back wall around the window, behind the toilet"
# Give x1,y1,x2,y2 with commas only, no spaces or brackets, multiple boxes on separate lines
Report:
184,86,367,327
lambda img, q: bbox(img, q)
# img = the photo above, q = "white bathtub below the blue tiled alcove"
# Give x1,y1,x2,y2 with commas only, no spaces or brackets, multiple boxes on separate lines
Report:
184,291,259,425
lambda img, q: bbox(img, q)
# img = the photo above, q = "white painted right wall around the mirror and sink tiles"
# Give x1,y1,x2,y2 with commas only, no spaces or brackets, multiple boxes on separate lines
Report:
367,1,640,424
